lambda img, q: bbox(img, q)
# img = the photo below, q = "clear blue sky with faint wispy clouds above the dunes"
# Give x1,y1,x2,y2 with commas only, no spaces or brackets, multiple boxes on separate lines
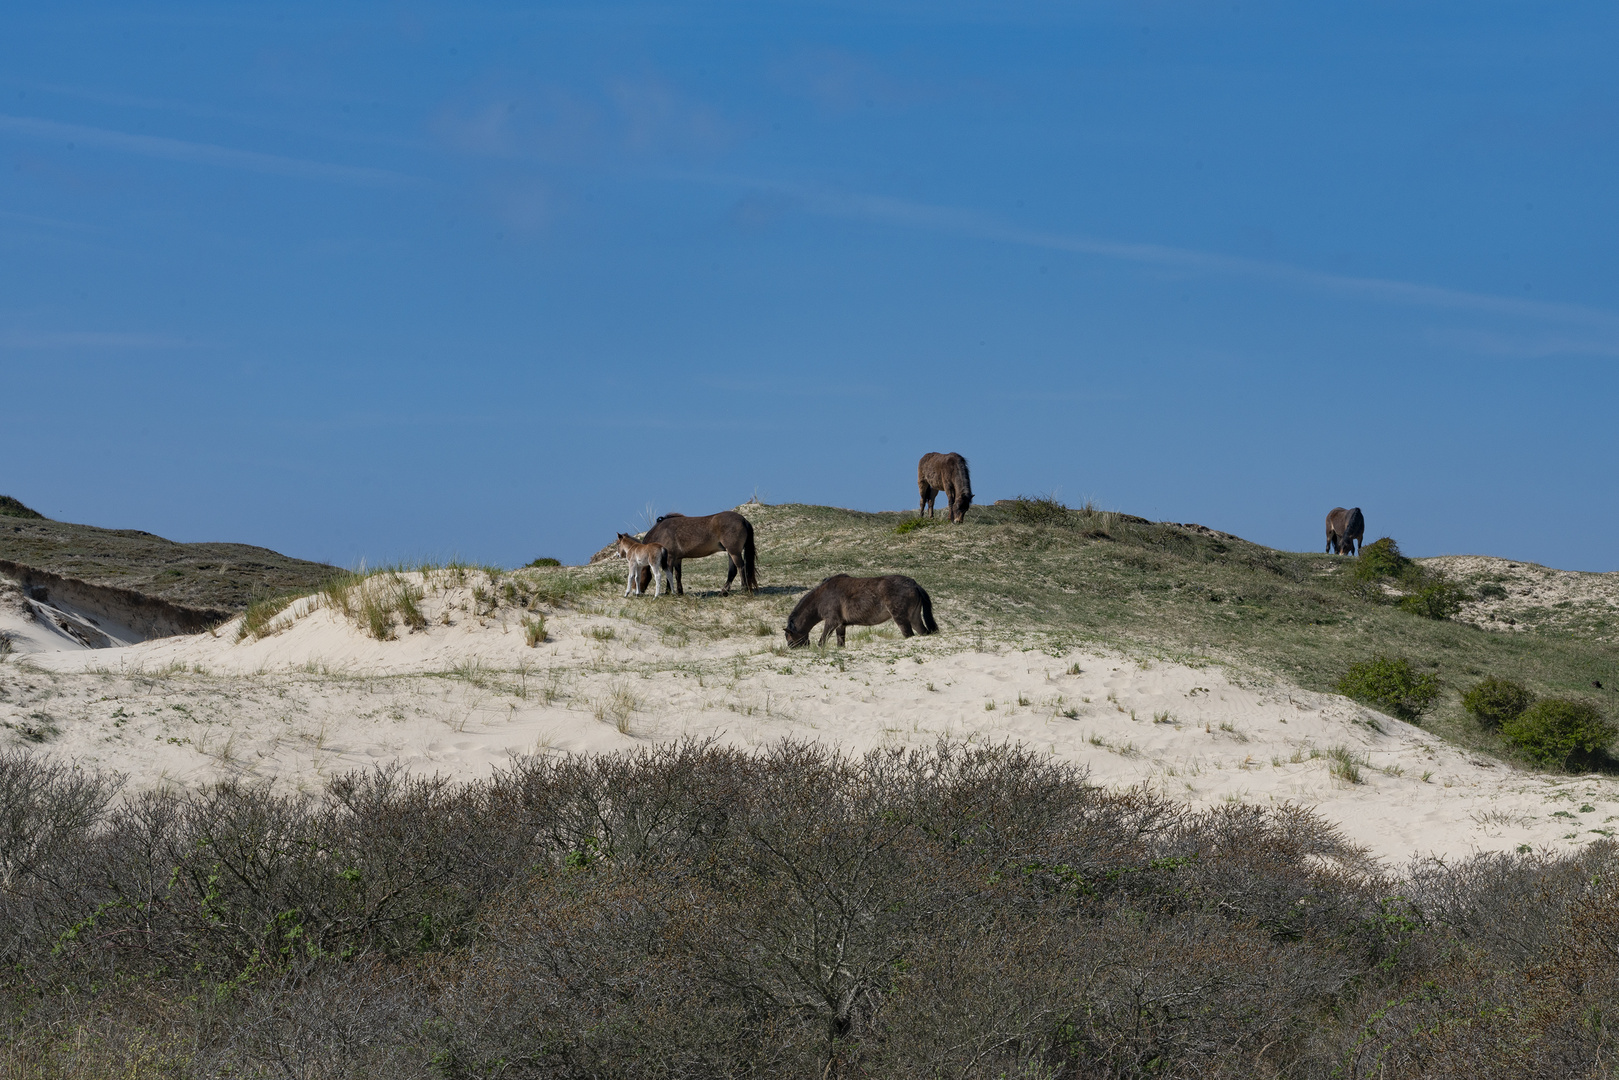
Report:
0,0,1619,570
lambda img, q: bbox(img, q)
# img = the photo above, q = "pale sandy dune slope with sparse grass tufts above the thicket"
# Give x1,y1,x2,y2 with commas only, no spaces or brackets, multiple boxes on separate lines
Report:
0,575,1619,861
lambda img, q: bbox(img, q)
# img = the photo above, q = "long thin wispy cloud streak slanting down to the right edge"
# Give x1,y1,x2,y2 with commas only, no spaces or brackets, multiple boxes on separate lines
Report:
683,173,1619,335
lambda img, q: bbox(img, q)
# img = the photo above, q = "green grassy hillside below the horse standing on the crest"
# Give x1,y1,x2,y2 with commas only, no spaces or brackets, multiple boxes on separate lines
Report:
725,499,1619,764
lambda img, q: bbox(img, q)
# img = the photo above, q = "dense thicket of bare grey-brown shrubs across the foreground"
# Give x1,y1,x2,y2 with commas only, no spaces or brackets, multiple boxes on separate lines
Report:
0,743,1619,1077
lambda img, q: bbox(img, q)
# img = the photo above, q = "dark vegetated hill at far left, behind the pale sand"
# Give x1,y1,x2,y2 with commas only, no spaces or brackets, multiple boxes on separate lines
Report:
0,495,337,612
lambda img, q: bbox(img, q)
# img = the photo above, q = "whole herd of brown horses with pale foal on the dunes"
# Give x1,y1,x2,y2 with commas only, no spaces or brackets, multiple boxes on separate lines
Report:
618,453,1366,649
